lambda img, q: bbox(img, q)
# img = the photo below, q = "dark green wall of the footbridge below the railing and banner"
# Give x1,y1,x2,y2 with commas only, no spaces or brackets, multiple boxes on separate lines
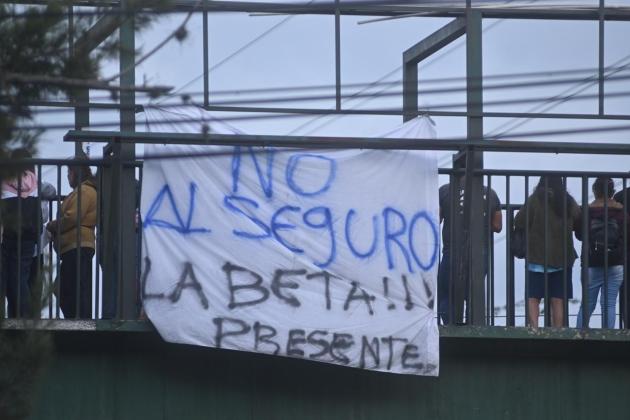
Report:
32,327,630,420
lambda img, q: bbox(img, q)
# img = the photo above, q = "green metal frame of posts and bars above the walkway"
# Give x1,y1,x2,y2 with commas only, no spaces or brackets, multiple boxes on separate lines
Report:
12,0,630,325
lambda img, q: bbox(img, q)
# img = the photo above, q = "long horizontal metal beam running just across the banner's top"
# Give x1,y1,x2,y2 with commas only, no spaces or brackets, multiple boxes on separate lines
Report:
63,130,630,155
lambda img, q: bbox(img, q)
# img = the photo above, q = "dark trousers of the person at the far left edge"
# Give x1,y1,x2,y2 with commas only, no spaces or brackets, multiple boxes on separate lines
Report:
2,239,35,318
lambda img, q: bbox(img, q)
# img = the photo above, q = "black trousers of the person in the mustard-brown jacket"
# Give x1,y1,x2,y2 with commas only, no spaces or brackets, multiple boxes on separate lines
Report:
59,248,94,319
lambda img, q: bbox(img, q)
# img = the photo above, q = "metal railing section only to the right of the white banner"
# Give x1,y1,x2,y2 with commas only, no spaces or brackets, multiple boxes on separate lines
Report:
438,169,630,328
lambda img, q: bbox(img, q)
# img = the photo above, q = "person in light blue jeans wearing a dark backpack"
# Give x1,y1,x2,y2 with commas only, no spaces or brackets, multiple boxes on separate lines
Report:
575,177,630,328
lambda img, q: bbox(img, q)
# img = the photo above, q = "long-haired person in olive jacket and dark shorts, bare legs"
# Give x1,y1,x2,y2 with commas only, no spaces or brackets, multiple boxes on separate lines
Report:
514,176,580,328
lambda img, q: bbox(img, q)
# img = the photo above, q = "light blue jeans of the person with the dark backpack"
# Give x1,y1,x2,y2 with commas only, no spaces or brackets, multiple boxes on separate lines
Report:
576,265,623,328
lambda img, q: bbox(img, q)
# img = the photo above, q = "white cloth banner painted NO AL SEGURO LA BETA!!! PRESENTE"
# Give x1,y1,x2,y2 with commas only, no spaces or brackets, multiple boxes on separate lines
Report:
142,107,439,376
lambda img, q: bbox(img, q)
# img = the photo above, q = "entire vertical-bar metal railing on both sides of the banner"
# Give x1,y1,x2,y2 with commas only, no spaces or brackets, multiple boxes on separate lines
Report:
0,159,630,328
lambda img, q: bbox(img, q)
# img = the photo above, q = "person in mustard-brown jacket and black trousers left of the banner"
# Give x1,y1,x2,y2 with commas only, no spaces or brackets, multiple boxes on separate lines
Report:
46,162,97,319
